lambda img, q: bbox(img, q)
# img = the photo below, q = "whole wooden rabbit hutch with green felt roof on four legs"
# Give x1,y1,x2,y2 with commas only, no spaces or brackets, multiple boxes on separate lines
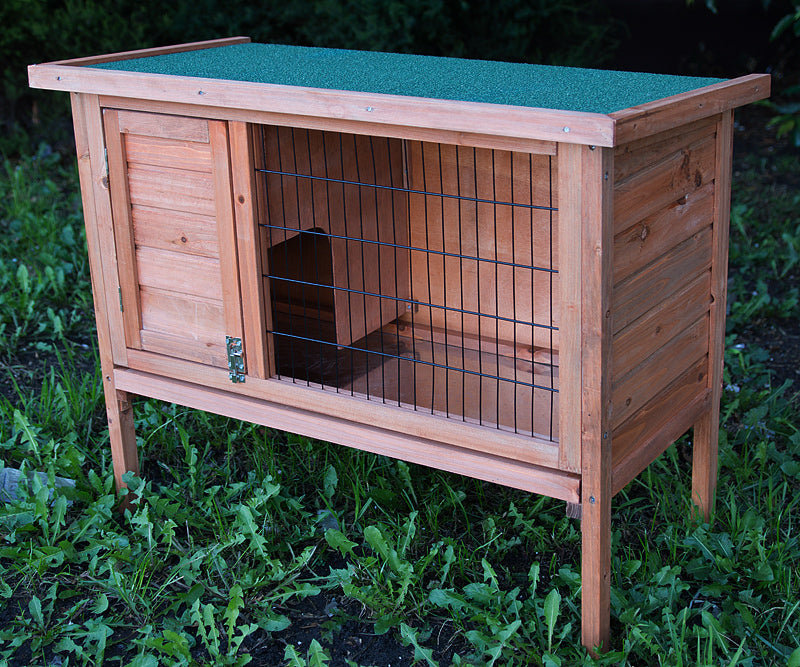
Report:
29,38,769,649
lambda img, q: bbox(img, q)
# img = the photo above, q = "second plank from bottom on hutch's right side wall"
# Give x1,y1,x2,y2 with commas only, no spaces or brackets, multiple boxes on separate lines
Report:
611,313,709,428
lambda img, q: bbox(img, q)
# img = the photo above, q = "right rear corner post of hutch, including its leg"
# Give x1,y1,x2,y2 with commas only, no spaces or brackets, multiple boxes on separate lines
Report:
692,111,733,521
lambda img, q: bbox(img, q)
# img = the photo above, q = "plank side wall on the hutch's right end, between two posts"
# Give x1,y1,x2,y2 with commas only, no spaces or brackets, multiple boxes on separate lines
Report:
611,117,718,493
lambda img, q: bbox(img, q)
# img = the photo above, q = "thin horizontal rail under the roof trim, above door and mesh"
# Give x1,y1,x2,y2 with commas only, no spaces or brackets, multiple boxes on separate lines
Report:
100,95,557,155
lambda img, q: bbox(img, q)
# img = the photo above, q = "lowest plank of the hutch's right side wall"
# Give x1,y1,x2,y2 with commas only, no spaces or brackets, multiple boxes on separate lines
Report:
612,356,710,494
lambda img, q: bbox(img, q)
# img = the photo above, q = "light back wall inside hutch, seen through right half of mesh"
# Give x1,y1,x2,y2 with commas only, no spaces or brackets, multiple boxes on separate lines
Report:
407,142,560,350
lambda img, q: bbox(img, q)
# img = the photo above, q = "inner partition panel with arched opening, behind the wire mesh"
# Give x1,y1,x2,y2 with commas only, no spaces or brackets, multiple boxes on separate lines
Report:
263,127,410,352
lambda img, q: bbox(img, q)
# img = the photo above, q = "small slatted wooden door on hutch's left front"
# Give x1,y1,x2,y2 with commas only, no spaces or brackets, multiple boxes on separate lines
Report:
103,109,242,368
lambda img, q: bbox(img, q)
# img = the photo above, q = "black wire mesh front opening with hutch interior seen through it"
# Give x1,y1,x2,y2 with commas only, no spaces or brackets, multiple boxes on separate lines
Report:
255,126,558,441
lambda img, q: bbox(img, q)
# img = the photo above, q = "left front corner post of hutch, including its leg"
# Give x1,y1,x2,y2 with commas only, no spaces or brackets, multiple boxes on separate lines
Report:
71,93,139,489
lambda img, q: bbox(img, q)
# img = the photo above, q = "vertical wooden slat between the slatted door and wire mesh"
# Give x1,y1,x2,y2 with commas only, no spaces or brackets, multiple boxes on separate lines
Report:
228,122,274,378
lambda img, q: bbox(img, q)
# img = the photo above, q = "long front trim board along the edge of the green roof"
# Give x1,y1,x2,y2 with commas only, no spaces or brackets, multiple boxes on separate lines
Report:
28,65,614,146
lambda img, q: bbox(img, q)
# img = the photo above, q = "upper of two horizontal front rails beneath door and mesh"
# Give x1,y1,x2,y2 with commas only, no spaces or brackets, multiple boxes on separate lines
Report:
129,350,558,469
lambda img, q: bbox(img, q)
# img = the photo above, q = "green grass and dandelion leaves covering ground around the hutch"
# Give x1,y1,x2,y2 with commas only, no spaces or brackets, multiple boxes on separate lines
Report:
0,137,800,667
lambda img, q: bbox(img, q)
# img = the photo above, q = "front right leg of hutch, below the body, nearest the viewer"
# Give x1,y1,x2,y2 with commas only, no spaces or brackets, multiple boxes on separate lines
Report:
581,480,611,657
